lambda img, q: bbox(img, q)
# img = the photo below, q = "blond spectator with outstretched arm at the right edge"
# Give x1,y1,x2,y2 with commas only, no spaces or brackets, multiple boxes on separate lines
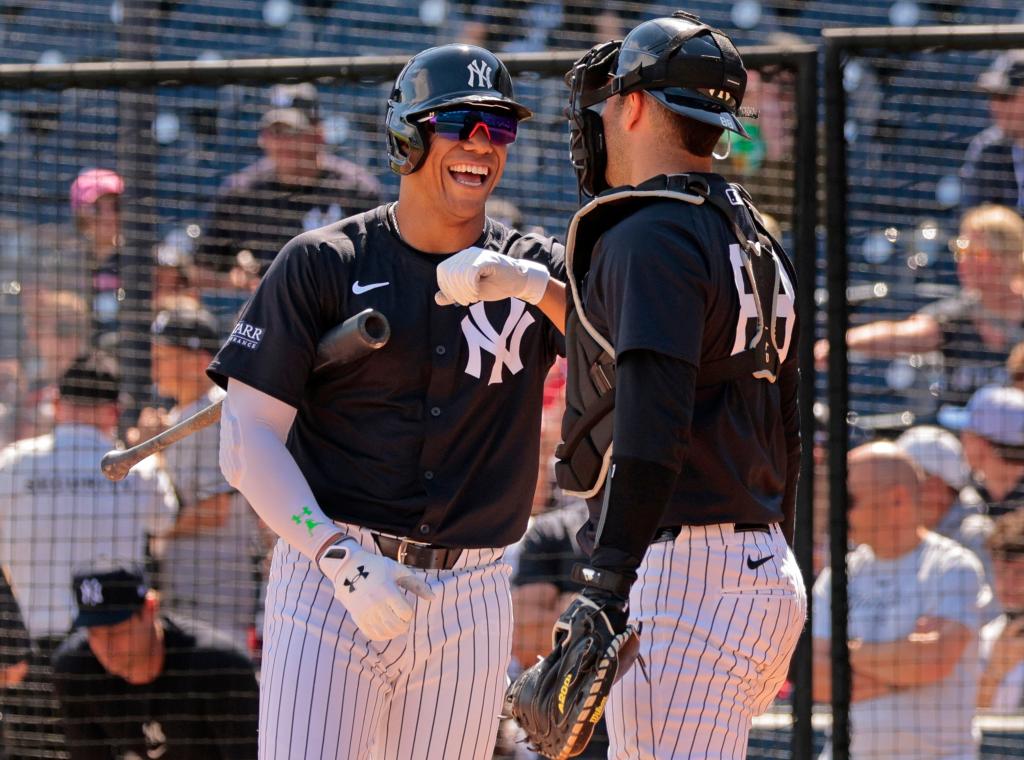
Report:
814,205,1024,413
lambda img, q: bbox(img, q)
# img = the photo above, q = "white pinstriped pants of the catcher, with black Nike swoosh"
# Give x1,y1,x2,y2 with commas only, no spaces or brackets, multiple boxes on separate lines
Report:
607,524,807,760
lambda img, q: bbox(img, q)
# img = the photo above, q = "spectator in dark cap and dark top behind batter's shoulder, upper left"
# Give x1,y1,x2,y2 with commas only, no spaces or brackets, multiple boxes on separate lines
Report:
194,83,381,323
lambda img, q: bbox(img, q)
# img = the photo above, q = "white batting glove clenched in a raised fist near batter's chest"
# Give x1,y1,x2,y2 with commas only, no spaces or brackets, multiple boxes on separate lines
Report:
434,246,551,306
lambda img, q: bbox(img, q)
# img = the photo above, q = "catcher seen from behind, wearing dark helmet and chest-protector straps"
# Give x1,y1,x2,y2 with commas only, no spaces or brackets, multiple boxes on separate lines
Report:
556,12,806,760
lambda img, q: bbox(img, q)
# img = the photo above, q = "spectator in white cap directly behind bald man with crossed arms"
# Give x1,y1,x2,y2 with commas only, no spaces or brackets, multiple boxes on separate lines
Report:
896,425,992,582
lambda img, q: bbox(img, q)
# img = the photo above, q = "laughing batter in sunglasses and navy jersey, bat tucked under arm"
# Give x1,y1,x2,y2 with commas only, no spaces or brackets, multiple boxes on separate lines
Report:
203,45,565,760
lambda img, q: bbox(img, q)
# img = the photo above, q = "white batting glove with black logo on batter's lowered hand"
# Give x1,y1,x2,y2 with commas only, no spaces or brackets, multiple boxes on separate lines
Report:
317,540,434,641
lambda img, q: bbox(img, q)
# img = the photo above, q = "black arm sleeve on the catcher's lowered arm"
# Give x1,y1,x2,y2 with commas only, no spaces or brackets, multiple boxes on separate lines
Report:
591,350,697,580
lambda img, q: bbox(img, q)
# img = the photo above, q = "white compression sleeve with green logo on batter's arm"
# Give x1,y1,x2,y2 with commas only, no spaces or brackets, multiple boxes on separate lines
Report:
220,380,344,562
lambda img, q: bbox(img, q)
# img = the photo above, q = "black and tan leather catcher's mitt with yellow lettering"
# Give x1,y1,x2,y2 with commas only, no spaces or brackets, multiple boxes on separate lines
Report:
504,594,639,760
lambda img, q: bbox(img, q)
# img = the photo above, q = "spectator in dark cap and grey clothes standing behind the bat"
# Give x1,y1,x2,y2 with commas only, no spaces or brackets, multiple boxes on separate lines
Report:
151,305,265,648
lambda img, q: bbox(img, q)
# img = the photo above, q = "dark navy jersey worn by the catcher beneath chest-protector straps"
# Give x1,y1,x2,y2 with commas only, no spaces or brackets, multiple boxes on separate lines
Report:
584,174,799,525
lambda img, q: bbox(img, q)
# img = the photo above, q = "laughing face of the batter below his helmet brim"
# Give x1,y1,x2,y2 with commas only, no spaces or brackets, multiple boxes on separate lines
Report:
401,110,508,220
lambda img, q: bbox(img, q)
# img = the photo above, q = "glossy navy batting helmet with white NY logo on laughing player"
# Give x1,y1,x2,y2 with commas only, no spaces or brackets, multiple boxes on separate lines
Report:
386,45,532,174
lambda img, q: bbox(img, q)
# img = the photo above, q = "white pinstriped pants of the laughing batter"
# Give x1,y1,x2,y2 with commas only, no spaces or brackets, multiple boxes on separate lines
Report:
259,526,512,760
